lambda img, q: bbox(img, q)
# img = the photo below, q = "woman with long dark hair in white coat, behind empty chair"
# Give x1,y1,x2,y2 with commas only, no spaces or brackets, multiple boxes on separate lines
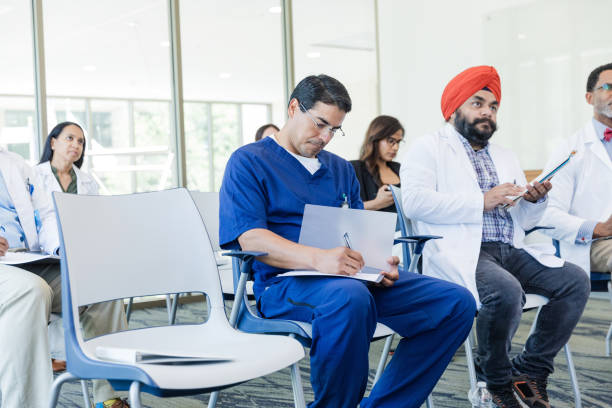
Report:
34,122,98,195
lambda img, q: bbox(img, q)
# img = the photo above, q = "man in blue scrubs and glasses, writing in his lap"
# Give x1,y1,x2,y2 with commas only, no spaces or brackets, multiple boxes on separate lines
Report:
220,75,476,408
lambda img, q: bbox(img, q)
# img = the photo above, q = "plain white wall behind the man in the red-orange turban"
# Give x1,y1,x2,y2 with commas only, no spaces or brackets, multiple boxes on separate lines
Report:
378,0,612,169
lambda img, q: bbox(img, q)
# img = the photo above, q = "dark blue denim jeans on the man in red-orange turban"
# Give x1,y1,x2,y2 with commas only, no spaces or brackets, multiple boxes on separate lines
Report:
476,242,591,385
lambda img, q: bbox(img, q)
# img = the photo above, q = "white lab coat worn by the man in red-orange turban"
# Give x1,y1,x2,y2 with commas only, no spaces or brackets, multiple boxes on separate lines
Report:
400,124,563,303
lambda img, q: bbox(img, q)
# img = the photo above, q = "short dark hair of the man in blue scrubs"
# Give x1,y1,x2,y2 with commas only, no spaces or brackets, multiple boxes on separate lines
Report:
289,74,352,113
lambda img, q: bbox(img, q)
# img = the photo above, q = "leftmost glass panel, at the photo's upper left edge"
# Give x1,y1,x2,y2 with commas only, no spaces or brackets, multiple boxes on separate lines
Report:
0,0,38,163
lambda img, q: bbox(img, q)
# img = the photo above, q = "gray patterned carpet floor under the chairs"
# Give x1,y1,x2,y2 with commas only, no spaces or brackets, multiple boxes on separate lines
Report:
53,299,612,408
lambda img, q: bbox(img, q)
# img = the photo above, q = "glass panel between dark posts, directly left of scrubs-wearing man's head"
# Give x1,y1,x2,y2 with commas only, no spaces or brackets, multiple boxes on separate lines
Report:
180,0,285,191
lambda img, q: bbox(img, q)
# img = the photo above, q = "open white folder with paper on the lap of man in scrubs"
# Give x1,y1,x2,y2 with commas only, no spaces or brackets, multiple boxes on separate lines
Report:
278,204,397,282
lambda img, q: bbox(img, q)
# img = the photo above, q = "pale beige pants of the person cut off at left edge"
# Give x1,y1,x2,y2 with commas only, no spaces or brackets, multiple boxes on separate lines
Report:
0,264,127,408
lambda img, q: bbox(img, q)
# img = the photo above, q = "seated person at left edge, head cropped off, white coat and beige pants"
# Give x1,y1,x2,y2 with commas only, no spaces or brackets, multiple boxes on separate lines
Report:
0,149,127,408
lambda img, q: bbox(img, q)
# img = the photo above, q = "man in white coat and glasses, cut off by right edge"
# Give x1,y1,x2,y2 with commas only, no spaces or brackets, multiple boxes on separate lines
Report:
542,63,612,273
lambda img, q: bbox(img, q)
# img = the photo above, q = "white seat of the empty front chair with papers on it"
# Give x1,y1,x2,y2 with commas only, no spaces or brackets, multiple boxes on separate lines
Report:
79,323,304,390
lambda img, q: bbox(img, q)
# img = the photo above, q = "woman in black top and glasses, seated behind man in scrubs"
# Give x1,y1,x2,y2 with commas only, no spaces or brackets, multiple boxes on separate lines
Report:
351,115,404,212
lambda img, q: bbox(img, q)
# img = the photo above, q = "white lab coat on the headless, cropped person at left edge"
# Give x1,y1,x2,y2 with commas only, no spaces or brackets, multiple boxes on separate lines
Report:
0,148,59,254
